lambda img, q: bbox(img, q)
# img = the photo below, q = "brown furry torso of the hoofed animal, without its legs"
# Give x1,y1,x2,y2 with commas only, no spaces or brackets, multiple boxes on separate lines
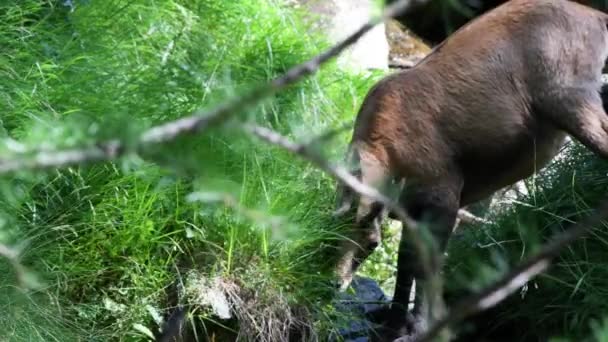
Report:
353,0,606,205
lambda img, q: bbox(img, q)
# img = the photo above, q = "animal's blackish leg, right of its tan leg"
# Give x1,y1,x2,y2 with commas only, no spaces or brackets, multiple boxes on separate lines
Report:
373,178,462,341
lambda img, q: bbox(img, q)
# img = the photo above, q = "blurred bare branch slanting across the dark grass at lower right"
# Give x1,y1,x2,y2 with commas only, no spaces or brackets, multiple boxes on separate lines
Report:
416,201,608,342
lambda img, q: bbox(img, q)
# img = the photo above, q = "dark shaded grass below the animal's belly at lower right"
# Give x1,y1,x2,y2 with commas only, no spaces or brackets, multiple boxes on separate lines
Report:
436,143,608,341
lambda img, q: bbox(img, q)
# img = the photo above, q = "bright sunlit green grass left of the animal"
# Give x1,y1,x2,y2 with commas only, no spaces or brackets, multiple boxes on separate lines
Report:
0,0,379,341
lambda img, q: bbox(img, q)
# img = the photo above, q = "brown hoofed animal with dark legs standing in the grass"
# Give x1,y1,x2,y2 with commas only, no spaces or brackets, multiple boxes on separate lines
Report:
337,0,608,340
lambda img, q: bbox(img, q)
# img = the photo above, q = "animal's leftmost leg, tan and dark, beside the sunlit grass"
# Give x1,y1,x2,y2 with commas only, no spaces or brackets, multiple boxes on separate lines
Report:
337,153,390,290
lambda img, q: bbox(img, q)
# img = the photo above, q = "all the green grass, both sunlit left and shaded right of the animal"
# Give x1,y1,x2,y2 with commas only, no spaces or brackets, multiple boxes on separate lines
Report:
8,0,608,341
